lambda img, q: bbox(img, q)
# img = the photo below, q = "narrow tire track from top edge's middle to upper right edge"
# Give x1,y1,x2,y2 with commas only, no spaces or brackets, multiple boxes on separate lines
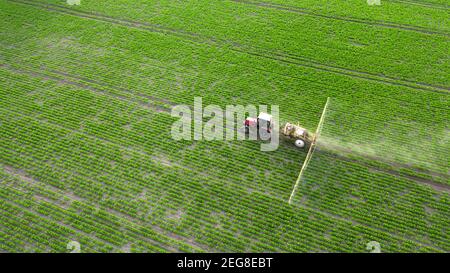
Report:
229,0,450,37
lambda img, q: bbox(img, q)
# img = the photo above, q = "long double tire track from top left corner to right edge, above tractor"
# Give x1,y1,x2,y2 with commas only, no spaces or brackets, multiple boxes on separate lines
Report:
8,0,450,94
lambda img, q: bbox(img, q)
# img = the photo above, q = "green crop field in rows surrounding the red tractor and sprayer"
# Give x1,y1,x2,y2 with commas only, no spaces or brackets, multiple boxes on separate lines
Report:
0,0,450,252
